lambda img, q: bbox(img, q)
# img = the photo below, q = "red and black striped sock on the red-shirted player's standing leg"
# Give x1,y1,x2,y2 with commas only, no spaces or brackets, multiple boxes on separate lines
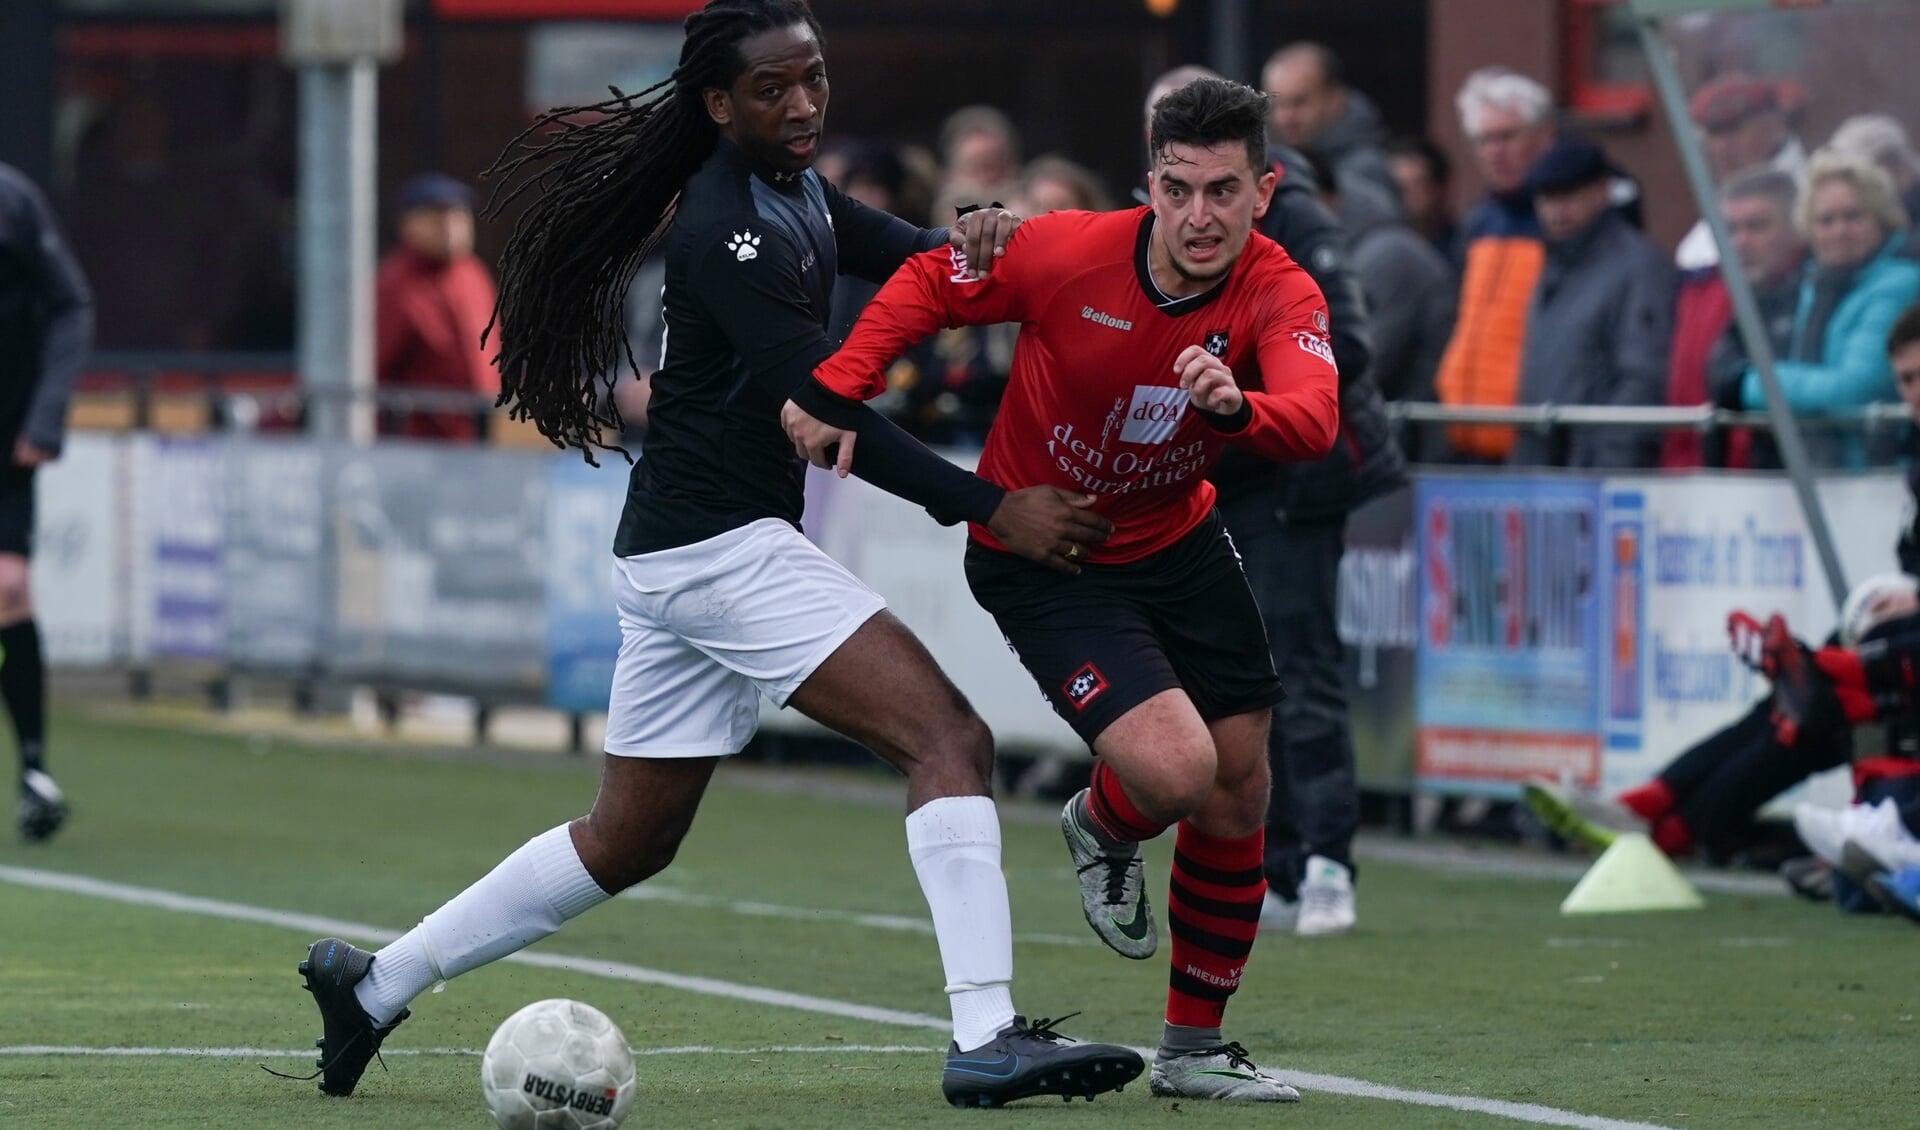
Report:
1167,821,1267,1028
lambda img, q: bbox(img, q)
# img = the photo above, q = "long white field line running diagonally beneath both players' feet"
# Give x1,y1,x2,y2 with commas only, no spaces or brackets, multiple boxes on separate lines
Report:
0,865,1668,1130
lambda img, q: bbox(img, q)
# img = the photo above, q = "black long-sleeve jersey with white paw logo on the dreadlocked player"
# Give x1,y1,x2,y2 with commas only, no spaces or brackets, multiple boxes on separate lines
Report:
614,140,1000,556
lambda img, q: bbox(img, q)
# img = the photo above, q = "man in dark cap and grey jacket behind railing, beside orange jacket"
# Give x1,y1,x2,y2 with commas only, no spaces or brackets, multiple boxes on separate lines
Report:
1507,138,1672,468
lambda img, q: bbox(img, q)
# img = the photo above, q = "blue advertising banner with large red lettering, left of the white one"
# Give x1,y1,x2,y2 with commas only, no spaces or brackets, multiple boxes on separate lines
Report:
1415,476,1603,792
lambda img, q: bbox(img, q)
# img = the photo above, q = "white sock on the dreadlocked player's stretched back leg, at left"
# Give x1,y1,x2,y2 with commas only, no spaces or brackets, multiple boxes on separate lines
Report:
353,825,611,1024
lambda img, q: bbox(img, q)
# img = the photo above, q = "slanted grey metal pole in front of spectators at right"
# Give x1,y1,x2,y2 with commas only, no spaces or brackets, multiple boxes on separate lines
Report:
1634,13,1847,608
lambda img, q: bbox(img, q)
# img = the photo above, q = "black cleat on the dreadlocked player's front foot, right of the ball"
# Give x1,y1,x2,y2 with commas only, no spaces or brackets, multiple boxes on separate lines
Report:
941,1017,1146,1107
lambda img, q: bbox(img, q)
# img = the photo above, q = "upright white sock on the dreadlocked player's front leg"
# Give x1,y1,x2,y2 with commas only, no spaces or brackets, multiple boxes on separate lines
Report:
906,796,1014,1051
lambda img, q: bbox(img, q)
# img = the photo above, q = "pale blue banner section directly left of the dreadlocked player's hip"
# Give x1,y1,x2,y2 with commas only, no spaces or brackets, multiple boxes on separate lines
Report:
545,455,628,712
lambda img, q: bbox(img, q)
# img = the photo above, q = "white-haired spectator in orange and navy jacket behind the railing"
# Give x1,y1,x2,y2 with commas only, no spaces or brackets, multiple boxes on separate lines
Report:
1436,67,1553,462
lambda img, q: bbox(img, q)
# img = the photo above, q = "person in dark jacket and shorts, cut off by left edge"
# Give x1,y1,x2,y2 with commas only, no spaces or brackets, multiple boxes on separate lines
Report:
0,165,94,842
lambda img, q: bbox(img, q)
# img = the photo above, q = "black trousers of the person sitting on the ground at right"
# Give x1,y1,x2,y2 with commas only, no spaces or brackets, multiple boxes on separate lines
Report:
1661,698,1853,854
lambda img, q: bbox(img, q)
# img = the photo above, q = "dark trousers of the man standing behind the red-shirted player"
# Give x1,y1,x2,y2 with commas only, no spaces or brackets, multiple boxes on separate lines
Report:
1221,493,1359,900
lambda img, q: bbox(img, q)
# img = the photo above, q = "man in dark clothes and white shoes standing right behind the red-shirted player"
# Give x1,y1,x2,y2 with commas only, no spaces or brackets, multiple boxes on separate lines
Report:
1146,67,1407,934
